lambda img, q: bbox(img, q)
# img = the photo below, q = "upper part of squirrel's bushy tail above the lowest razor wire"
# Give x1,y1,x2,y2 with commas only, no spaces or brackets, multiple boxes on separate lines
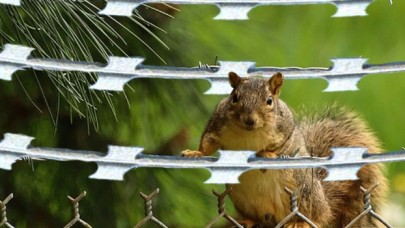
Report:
299,104,382,157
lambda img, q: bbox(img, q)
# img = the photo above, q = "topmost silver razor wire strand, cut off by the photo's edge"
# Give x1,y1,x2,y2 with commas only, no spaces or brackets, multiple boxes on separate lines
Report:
0,0,392,20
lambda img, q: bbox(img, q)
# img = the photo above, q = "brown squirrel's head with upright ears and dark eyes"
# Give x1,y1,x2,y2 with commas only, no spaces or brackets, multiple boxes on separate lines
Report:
227,72,294,131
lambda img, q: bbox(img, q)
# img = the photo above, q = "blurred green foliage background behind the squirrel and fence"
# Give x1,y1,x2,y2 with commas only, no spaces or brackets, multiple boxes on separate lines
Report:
0,0,405,227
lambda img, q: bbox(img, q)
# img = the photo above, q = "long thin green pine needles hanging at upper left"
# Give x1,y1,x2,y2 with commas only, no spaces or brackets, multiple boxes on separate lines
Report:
0,1,172,130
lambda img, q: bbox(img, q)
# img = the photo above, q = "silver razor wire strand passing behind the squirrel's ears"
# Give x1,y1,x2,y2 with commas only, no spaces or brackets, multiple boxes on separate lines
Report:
0,44,405,94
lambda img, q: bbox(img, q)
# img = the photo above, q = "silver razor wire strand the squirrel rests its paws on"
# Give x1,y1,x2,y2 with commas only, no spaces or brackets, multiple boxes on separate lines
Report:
0,133,405,184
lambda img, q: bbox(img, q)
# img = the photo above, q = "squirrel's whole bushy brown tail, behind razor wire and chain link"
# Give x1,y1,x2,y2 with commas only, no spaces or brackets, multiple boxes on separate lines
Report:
299,104,388,227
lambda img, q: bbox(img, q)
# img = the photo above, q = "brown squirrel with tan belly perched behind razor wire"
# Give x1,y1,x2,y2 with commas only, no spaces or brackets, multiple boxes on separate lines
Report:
182,72,388,227
